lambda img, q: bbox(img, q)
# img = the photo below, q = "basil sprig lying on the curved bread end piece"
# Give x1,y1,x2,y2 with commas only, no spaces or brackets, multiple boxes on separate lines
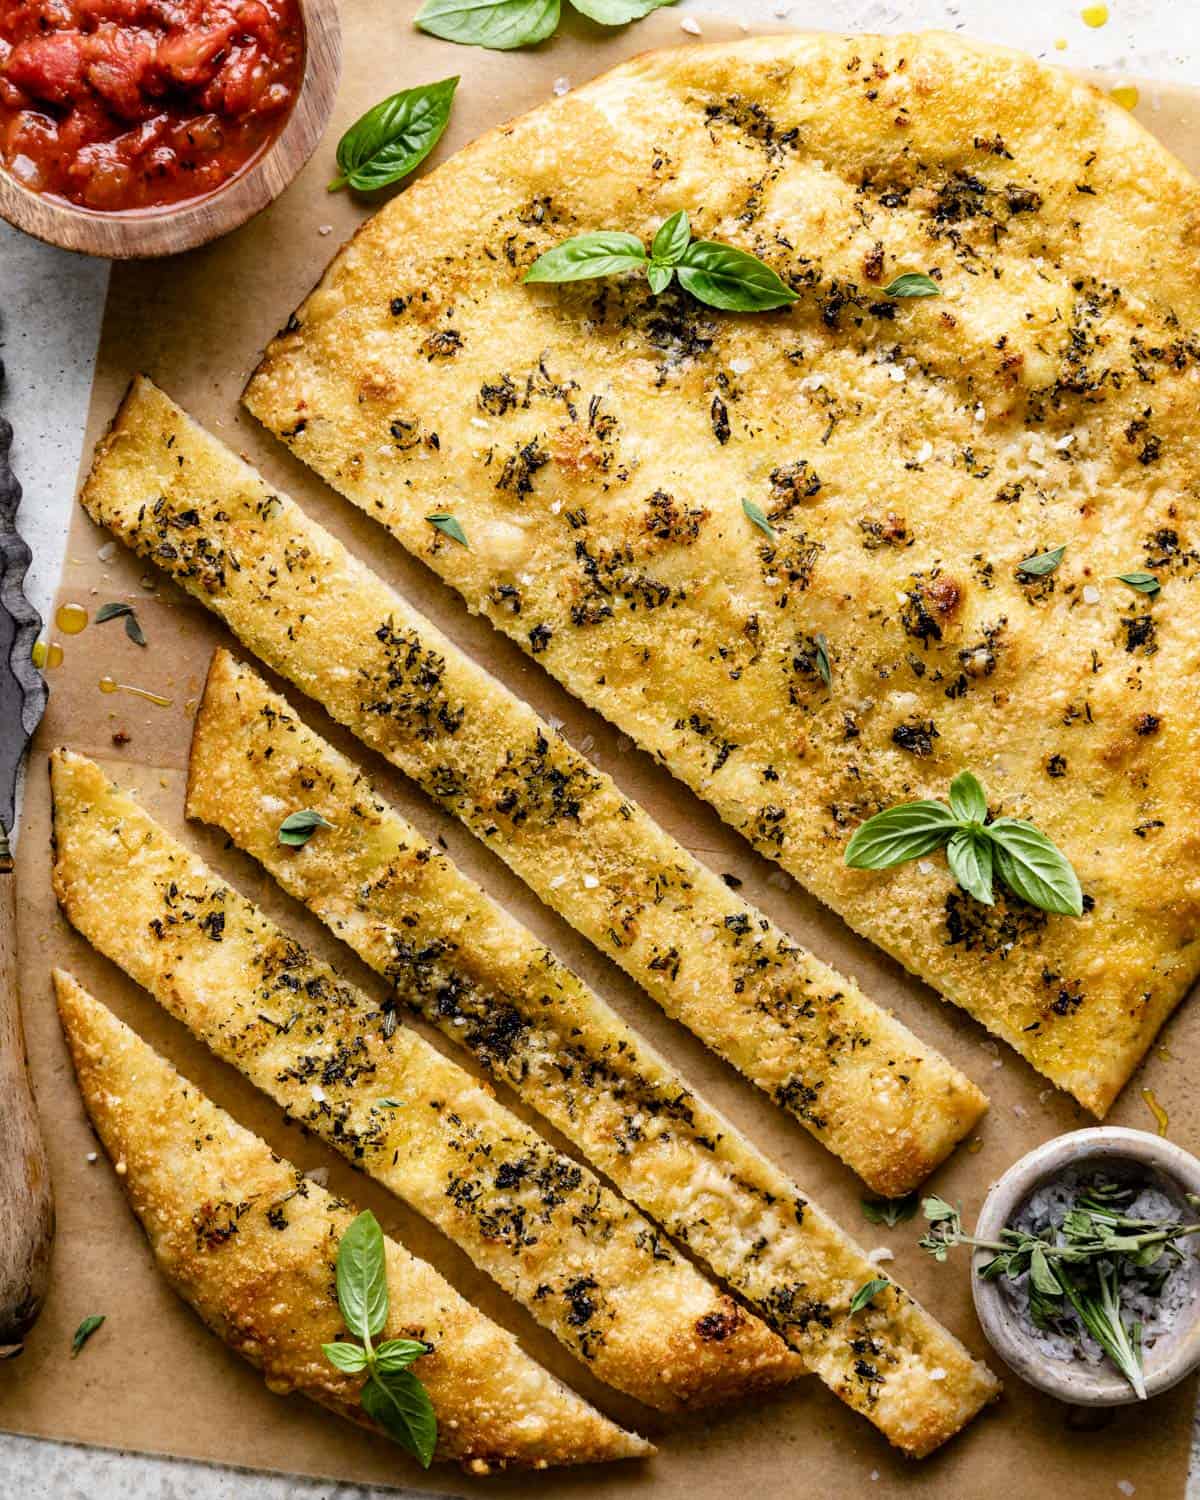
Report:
321,1211,438,1469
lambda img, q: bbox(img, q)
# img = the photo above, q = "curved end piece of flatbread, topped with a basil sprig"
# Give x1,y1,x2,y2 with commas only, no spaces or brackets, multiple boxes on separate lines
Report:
54,969,654,1475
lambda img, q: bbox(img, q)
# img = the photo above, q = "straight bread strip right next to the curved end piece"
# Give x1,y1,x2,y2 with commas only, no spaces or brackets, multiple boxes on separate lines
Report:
51,750,801,1410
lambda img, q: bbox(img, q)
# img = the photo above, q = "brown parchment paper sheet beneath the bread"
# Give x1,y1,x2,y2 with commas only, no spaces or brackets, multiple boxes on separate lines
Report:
0,0,1200,1500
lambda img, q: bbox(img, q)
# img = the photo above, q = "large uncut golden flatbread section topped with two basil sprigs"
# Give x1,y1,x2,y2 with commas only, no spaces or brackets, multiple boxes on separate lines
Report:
246,35,1200,1115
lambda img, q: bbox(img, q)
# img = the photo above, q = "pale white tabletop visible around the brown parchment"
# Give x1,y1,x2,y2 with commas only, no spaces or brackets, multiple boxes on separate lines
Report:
0,0,1200,1500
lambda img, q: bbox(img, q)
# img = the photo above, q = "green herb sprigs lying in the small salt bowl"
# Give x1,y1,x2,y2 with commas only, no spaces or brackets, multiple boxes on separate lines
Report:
920,1182,1200,1401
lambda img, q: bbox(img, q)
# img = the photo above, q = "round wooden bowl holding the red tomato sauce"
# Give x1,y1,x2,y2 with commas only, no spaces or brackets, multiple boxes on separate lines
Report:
0,0,342,261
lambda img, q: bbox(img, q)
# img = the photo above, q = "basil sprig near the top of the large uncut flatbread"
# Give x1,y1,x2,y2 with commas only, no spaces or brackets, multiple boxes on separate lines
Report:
524,209,797,312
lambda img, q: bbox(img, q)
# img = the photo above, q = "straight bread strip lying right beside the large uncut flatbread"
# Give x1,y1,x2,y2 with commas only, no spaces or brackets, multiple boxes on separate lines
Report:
83,380,986,1196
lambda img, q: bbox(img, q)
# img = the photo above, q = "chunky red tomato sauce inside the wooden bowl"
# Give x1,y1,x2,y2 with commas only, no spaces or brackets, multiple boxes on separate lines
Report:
0,0,305,212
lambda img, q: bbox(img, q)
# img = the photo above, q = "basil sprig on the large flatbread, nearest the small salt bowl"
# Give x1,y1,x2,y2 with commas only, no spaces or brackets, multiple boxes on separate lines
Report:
846,771,1083,917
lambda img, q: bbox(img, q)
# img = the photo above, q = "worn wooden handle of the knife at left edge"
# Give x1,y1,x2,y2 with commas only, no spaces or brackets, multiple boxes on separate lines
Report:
0,858,54,1359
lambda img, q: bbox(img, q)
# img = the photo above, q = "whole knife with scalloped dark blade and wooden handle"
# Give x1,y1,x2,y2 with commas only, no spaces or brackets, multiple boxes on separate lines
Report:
0,365,54,1359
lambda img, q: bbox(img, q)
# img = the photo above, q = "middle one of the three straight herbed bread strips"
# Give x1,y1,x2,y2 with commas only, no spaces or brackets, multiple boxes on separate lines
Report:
188,651,998,1454
